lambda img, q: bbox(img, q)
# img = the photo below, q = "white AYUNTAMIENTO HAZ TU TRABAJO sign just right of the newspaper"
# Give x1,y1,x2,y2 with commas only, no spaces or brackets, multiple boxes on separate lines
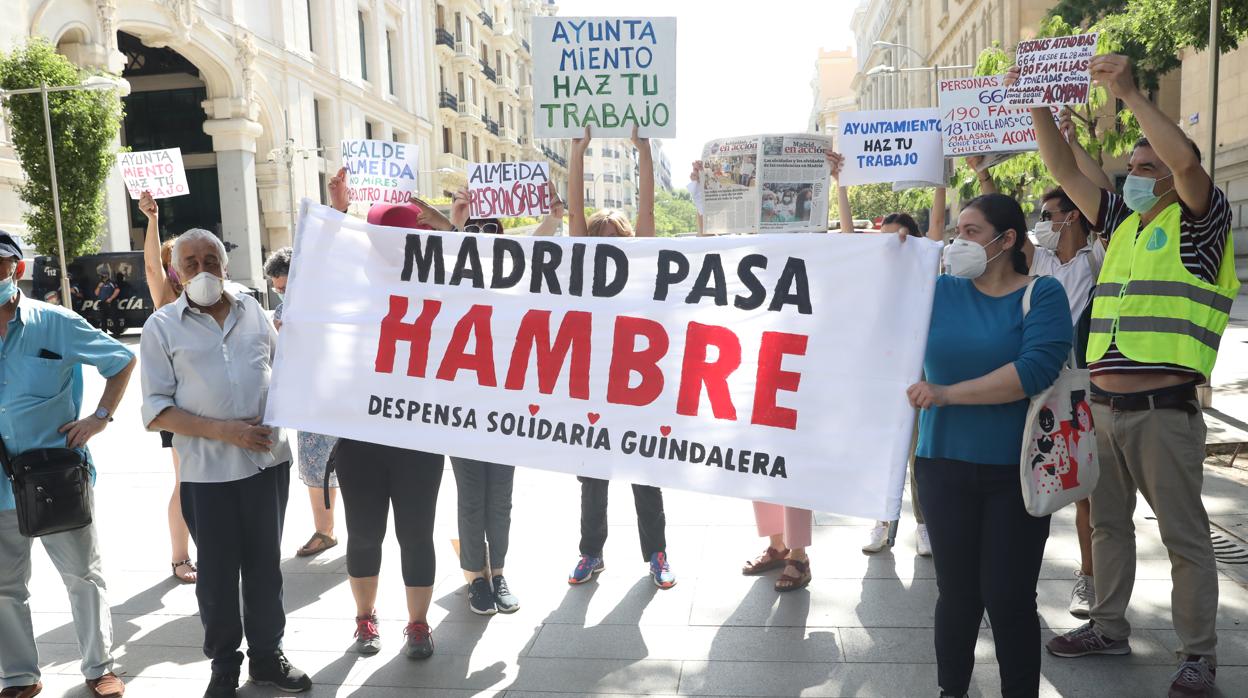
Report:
836,109,945,186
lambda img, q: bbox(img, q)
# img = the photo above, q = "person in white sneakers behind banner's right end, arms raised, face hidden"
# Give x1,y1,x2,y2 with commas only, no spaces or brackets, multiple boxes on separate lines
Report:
827,151,946,557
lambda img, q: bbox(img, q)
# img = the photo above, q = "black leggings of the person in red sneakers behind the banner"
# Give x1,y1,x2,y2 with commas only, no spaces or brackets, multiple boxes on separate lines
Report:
334,438,443,587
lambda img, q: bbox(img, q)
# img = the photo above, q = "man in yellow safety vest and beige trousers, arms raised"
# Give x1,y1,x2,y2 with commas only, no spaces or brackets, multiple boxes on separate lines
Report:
1006,55,1239,697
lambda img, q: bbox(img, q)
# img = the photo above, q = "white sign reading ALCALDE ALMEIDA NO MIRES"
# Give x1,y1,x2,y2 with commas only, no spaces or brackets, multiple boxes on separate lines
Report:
342,139,421,205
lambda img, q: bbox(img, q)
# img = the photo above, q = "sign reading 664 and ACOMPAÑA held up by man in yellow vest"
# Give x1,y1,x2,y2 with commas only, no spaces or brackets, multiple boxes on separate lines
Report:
1006,34,1098,106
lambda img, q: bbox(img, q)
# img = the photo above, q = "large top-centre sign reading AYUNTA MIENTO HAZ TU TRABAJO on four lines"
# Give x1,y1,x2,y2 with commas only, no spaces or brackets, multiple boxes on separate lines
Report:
533,17,676,139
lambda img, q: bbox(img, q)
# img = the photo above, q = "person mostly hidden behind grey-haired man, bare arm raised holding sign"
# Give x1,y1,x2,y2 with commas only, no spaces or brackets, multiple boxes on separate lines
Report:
139,191,198,584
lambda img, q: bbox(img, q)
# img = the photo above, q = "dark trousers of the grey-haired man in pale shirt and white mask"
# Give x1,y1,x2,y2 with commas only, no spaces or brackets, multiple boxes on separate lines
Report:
182,463,291,673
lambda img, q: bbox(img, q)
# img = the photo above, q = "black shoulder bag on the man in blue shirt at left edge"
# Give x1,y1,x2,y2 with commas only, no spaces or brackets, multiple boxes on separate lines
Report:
0,441,92,538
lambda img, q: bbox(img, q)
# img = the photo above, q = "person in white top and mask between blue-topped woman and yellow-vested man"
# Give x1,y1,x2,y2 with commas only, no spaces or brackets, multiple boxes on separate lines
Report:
966,116,1114,618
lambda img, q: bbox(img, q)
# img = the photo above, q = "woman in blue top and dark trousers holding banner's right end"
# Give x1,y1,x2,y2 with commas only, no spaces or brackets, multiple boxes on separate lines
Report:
907,194,1071,697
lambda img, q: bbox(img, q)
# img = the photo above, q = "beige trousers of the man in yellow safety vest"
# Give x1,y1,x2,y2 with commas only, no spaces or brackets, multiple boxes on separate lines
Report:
1092,402,1218,661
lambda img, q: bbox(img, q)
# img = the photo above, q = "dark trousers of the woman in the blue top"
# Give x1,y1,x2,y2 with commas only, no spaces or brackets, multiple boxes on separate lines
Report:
915,458,1050,698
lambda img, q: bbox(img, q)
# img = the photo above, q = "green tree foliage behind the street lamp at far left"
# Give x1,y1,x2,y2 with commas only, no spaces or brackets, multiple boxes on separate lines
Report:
0,37,122,258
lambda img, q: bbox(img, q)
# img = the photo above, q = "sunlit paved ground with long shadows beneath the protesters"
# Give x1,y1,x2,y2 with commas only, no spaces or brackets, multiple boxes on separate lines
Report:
17,327,1248,698
